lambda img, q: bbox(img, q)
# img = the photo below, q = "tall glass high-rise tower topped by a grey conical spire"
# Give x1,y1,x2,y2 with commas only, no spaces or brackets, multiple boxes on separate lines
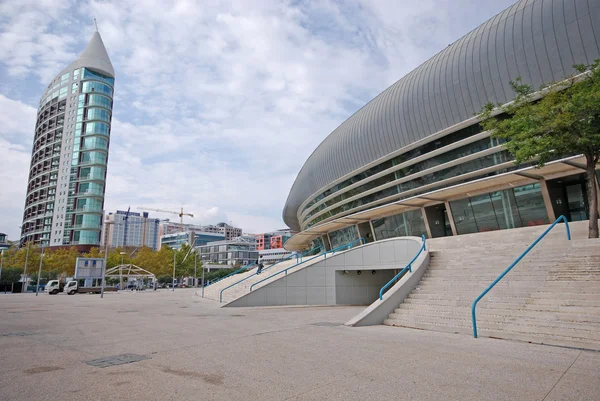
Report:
21,32,115,246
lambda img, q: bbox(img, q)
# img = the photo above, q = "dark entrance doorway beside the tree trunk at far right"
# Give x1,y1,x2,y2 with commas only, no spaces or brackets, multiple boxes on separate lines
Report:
548,174,590,221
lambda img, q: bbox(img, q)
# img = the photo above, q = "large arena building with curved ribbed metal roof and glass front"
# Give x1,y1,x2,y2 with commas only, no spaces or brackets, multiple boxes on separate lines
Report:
283,0,600,250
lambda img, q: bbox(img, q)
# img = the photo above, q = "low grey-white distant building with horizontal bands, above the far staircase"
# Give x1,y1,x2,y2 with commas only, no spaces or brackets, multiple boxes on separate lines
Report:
197,236,258,266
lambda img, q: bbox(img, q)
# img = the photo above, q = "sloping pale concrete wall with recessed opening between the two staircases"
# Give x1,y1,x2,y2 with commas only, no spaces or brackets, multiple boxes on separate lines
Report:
225,237,421,307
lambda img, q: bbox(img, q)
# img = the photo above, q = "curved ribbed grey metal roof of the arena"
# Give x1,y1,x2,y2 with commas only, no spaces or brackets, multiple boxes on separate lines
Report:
283,0,600,230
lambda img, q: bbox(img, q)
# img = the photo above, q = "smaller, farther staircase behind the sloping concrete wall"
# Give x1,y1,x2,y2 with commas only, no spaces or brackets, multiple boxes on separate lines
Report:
196,252,328,304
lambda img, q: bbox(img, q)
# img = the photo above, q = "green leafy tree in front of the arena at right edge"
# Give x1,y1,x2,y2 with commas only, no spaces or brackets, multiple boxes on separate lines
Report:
480,60,600,238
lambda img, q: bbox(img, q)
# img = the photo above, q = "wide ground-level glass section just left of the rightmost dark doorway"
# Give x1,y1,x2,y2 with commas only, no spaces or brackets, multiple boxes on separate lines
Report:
450,183,549,235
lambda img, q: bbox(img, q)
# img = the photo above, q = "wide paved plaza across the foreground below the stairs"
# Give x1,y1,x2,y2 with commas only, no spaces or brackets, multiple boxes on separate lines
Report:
0,290,600,401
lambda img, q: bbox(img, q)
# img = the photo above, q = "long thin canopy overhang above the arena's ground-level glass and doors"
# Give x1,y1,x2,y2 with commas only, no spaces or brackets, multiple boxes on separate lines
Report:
284,156,585,251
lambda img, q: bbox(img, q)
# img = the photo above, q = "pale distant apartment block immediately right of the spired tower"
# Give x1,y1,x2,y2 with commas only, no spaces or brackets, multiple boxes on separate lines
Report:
102,210,160,250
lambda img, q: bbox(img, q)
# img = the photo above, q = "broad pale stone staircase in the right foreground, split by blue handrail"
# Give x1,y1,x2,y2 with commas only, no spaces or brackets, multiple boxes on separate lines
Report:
384,222,600,350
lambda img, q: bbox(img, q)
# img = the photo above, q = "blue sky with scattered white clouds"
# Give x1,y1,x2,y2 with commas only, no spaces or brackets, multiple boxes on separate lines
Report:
0,0,513,240
